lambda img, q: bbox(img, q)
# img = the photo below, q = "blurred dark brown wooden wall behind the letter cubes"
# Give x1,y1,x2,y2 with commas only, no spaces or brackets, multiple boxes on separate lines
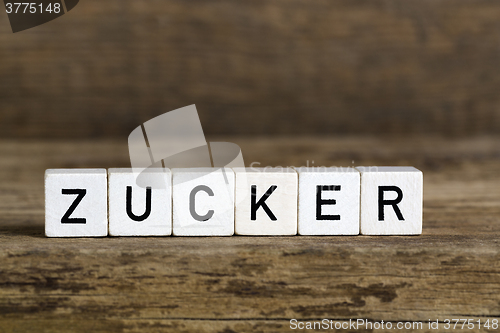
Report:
0,0,500,138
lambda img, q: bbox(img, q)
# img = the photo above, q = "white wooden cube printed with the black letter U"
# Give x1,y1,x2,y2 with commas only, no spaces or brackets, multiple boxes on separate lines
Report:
108,168,172,236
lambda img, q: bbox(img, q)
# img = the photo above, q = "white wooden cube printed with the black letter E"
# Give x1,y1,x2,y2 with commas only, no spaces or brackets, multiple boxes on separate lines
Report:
296,167,360,235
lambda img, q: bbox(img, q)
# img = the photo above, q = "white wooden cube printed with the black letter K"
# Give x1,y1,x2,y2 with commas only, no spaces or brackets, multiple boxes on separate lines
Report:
233,167,298,236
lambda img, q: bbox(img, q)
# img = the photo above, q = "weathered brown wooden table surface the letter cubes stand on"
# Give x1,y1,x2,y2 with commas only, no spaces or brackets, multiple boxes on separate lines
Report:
0,136,500,333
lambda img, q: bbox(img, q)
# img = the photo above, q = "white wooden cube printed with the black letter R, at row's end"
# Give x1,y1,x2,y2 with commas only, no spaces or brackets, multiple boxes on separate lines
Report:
356,166,423,235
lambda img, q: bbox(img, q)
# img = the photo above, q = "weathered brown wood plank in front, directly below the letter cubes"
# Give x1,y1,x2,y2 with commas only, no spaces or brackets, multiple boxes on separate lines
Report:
0,227,500,321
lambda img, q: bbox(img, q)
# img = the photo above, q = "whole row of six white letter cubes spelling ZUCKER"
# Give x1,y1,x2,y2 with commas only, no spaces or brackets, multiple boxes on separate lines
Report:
45,167,423,237
